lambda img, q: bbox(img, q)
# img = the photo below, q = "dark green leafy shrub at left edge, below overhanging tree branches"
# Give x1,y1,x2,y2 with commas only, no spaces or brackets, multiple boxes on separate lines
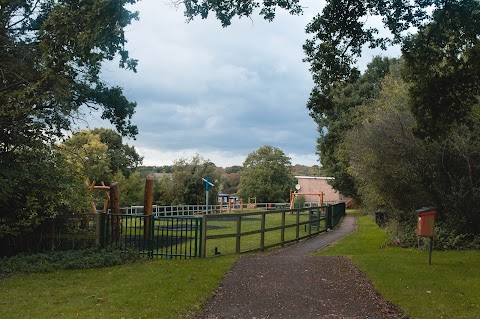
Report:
0,149,88,241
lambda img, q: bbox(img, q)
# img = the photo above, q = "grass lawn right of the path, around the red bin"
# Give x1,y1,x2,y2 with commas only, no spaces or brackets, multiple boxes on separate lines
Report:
318,212,480,319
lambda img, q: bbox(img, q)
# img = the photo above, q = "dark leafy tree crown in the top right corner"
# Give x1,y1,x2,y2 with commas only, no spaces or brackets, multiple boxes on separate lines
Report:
402,0,480,138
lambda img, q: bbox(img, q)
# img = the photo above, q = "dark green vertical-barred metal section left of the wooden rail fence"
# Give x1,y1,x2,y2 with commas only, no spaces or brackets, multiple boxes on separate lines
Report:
100,213,202,259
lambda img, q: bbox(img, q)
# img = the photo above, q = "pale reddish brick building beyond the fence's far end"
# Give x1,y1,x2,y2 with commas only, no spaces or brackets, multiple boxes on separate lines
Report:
295,176,349,202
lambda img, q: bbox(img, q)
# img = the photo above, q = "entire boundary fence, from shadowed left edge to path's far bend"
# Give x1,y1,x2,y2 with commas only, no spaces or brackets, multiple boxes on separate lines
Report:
0,203,345,258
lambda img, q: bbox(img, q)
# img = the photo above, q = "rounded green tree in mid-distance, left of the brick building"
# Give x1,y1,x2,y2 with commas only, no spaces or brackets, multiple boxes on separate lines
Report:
238,145,295,203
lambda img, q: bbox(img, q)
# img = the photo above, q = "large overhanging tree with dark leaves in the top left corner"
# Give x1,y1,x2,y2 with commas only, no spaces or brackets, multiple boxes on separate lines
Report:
0,0,141,152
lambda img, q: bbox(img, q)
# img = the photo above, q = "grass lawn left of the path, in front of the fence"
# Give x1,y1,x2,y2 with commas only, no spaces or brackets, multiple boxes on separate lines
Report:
0,256,238,319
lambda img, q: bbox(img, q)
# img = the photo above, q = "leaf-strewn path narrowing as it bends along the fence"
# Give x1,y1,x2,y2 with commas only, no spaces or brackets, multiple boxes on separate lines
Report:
199,216,407,319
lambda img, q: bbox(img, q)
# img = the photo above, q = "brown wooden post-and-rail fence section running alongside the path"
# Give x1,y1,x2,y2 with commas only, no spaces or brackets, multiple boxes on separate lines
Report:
201,205,345,257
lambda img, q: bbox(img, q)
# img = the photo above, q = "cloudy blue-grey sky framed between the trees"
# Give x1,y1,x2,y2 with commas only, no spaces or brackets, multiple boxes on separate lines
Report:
88,0,398,167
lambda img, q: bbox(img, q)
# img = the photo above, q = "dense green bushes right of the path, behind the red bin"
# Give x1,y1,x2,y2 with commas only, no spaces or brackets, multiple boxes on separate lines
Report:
343,64,480,248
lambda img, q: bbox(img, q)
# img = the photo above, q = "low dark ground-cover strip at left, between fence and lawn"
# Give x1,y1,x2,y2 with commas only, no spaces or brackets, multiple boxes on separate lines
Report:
0,247,140,277
